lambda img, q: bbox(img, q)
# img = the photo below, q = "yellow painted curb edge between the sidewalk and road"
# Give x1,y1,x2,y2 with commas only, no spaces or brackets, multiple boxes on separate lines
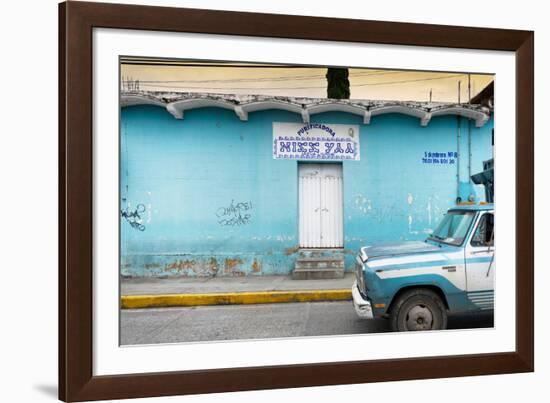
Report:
121,288,351,309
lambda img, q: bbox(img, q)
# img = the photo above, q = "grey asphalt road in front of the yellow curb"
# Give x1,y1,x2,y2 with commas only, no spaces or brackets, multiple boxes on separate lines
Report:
120,301,493,345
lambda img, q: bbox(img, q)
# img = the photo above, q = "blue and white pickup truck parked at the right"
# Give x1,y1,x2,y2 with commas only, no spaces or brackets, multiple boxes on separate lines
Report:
352,204,495,331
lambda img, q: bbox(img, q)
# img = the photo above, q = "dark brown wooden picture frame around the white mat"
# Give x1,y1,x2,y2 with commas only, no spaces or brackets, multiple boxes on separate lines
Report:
59,2,534,401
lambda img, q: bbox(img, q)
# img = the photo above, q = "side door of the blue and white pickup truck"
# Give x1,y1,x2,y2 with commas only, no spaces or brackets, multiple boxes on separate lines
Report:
464,211,496,309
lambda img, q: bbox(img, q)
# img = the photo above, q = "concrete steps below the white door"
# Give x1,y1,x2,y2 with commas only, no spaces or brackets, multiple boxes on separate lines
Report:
292,254,344,280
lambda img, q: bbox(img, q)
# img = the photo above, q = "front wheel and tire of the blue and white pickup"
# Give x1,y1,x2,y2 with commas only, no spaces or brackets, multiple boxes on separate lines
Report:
390,288,447,332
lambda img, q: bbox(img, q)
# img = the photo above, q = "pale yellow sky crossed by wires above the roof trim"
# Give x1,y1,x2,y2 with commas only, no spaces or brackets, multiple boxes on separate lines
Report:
121,58,494,102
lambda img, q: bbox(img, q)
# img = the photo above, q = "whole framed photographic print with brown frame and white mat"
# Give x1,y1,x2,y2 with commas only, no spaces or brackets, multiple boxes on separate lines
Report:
59,2,534,401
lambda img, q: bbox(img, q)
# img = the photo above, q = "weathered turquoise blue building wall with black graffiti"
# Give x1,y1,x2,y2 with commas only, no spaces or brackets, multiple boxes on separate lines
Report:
120,106,493,277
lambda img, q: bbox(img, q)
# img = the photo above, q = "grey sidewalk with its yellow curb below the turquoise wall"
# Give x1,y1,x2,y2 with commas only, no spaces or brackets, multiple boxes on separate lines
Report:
121,273,355,309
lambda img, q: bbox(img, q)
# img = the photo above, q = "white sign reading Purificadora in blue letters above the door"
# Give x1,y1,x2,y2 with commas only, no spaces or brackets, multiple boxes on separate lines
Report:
273,122,359,161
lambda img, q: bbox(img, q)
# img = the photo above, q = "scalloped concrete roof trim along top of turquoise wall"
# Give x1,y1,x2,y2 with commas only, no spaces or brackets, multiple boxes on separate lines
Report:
121,93,490,127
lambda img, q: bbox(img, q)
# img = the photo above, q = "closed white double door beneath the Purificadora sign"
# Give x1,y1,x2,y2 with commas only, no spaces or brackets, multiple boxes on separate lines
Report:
298,163,344,248
